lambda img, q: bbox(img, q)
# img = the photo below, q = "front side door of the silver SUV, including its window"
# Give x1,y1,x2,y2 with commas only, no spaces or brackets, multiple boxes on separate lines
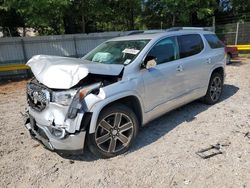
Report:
142,37,185,112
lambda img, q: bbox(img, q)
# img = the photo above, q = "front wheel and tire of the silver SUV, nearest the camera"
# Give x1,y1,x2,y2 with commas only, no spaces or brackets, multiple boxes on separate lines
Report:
87,104,139,158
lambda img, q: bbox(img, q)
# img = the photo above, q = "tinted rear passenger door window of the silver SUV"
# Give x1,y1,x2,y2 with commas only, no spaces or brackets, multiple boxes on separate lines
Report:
177,34,204,58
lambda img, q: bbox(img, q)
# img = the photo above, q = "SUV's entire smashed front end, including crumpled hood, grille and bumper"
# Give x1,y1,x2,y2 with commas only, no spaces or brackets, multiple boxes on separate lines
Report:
25,56,123,153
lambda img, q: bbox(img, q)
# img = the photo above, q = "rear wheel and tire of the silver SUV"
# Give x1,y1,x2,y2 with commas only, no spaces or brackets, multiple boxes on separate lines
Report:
203,72,223,105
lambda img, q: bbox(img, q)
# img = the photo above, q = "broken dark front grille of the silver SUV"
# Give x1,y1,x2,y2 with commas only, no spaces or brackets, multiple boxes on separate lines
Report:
27,83,50,111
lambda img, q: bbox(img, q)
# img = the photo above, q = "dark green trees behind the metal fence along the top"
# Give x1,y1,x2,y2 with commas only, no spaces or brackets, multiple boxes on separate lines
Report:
0,0,250,35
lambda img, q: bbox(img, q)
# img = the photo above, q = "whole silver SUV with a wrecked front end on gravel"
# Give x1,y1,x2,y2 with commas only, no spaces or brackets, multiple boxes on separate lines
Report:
25,29,226,158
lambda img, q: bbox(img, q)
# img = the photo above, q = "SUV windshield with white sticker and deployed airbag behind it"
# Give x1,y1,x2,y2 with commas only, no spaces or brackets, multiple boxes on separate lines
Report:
83,40,149,65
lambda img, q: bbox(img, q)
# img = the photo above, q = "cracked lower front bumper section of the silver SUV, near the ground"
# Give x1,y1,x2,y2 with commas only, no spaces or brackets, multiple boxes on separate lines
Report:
25,116,86,154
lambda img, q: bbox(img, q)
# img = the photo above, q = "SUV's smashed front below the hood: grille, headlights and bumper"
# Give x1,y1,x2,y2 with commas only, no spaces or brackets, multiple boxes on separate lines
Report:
25,79,101,153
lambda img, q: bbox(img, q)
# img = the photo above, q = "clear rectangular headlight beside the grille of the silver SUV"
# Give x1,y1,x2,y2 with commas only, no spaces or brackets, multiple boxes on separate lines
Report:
52,90,77,106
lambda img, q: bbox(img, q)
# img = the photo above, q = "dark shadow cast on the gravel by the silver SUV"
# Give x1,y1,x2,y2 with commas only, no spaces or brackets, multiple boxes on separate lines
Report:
62,84,239,161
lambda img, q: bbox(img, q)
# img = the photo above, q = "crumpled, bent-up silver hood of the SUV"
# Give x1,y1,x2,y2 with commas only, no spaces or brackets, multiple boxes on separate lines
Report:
26,55,124,89
